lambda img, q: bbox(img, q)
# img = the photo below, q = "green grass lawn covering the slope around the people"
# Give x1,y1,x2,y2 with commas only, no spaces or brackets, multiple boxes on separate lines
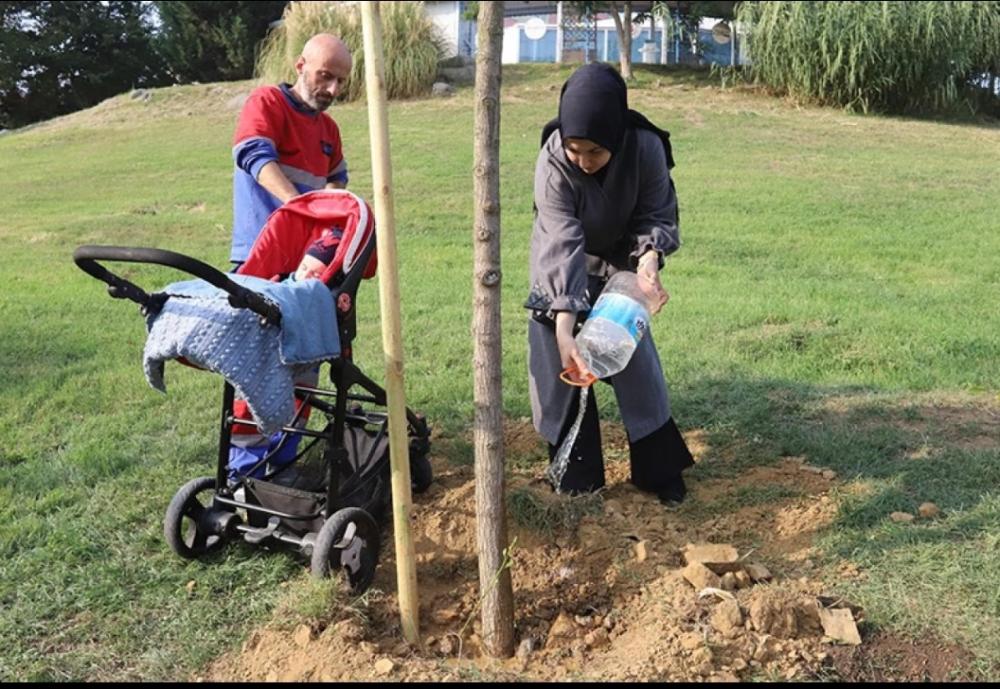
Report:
0,66,1000,681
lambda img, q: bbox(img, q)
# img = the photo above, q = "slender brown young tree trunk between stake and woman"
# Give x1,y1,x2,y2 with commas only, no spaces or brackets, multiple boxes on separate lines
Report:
472,2,514,657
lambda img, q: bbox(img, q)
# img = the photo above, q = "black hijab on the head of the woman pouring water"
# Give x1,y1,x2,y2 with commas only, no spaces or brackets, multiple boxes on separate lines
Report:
542,62,674,169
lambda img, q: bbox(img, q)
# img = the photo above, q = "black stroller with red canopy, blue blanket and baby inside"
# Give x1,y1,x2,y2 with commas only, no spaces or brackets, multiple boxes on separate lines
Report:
74,190,432,593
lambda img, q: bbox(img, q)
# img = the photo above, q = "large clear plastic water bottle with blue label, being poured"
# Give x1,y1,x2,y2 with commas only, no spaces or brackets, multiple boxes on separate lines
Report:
576,271,649,378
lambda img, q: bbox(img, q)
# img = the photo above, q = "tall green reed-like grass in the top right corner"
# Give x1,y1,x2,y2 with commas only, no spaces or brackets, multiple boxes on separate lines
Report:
738,0,1000,114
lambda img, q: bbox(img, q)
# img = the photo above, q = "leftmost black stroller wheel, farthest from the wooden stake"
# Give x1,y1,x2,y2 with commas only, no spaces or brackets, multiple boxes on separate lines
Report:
163,476,236,560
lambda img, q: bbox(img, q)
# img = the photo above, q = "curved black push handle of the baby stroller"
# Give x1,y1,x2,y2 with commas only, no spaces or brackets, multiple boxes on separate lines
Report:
73,244,281,326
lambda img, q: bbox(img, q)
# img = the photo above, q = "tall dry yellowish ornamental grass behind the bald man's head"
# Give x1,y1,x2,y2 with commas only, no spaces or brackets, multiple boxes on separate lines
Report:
256,2,444,100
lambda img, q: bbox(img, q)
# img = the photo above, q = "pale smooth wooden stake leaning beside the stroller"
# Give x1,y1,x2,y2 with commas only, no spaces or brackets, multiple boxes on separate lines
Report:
361,2,420,645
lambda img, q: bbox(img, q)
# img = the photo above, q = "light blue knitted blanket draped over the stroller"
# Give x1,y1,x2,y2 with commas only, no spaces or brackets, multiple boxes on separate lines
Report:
143,275,340,434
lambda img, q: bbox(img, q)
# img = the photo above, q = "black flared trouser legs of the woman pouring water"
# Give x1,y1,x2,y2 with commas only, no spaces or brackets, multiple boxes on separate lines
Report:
549,386,694,494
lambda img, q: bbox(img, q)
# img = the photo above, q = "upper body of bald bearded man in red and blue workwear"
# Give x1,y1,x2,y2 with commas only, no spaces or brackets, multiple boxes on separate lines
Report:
230,34,352,264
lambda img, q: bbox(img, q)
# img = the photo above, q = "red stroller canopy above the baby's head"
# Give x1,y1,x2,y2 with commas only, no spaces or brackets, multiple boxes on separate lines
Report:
236,189,377,285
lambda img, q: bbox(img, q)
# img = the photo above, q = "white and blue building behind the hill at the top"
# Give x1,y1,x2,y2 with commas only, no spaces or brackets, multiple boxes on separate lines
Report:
424,1,746,65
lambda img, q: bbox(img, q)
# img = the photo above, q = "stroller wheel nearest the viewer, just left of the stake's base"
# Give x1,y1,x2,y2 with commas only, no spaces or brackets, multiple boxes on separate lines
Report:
312,507,379,595
